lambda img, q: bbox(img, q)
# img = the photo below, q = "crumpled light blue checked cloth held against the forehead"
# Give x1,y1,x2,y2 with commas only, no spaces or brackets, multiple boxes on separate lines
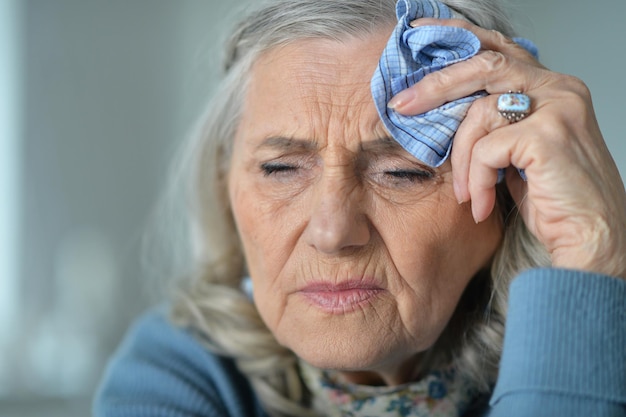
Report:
371,0,537,167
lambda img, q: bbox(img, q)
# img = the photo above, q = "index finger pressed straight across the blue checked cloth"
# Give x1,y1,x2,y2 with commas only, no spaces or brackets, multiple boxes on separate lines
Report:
389,51,547,115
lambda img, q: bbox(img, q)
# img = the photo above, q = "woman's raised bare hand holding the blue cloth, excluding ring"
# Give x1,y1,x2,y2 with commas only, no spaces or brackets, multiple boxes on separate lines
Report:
390,19,626,279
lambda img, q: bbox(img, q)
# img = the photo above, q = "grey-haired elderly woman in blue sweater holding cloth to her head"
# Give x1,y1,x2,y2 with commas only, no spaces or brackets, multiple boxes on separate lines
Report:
95,0,626,417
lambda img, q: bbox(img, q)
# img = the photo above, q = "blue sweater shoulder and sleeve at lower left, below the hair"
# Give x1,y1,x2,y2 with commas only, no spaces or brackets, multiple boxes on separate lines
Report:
93,309,263,417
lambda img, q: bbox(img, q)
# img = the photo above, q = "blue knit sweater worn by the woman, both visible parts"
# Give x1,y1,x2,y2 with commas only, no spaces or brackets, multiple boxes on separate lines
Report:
94,269,626,417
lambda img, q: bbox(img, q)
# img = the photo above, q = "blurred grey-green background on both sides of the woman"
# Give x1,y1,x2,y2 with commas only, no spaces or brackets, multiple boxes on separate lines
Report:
0,0,626,417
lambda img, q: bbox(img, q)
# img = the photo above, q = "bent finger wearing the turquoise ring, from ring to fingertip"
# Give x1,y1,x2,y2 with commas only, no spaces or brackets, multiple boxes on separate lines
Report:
450,95,509,203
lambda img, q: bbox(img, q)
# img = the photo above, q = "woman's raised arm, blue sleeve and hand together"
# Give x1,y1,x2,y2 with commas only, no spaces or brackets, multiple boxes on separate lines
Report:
390,19,626,417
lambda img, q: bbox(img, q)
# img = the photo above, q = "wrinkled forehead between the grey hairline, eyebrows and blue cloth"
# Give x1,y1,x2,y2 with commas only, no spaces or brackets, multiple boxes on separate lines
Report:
242,31,388,145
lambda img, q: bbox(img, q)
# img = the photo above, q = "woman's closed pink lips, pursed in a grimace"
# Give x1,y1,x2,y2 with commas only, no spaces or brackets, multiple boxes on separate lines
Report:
299,280,384,314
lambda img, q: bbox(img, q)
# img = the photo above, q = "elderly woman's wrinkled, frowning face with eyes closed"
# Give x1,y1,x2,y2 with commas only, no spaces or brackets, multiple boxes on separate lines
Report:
228,33,502,382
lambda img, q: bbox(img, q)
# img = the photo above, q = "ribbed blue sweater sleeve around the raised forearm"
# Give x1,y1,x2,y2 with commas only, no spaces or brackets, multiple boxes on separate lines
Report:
489,269,626,417
